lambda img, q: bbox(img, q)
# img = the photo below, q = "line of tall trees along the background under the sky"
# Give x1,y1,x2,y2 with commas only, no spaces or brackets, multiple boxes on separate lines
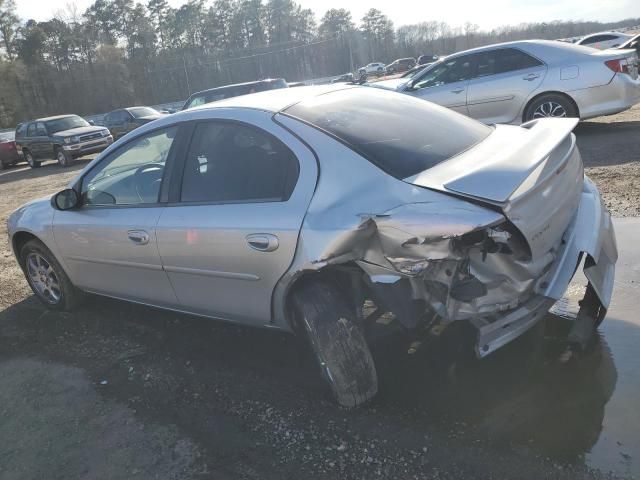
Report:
0,0,640,127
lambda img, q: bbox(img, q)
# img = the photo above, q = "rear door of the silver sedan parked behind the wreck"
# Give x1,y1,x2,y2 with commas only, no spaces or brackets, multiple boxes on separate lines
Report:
467,48,547,124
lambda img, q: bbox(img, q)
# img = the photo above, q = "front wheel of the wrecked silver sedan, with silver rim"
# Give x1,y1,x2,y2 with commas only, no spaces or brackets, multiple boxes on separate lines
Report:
20,239,81,311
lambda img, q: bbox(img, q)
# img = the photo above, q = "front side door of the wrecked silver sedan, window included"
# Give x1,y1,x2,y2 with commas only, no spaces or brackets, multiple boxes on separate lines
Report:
53,127,185,307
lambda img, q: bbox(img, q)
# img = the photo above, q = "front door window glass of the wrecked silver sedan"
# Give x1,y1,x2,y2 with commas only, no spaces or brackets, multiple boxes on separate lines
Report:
82,127,178,205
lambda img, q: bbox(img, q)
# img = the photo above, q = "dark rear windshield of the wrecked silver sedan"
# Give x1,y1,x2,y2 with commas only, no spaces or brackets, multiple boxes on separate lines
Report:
285,87,493,179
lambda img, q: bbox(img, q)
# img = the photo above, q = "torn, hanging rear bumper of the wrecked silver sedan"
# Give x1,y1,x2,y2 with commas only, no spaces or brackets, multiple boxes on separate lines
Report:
472,177,618,357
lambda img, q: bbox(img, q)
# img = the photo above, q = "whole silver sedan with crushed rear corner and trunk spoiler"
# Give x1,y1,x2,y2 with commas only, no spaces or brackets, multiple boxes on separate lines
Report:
8,86,617,406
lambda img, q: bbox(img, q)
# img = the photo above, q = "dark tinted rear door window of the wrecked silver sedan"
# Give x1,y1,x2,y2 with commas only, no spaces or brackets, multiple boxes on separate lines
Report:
181,122,299,203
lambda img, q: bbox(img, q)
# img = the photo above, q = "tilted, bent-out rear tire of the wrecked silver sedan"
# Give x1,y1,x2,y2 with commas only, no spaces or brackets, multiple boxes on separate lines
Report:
293,282,378,407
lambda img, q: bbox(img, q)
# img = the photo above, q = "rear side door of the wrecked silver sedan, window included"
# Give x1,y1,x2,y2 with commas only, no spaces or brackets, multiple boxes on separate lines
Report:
157,111,317,325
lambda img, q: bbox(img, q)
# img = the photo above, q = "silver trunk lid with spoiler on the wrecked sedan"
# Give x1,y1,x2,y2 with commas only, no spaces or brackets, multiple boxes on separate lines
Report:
405,118,584,258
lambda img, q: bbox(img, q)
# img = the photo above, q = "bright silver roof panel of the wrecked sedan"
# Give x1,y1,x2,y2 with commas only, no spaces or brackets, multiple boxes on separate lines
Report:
185,84,356,113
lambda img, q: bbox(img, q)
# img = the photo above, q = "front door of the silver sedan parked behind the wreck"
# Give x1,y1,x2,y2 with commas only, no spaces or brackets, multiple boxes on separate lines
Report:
406,55,472,115
